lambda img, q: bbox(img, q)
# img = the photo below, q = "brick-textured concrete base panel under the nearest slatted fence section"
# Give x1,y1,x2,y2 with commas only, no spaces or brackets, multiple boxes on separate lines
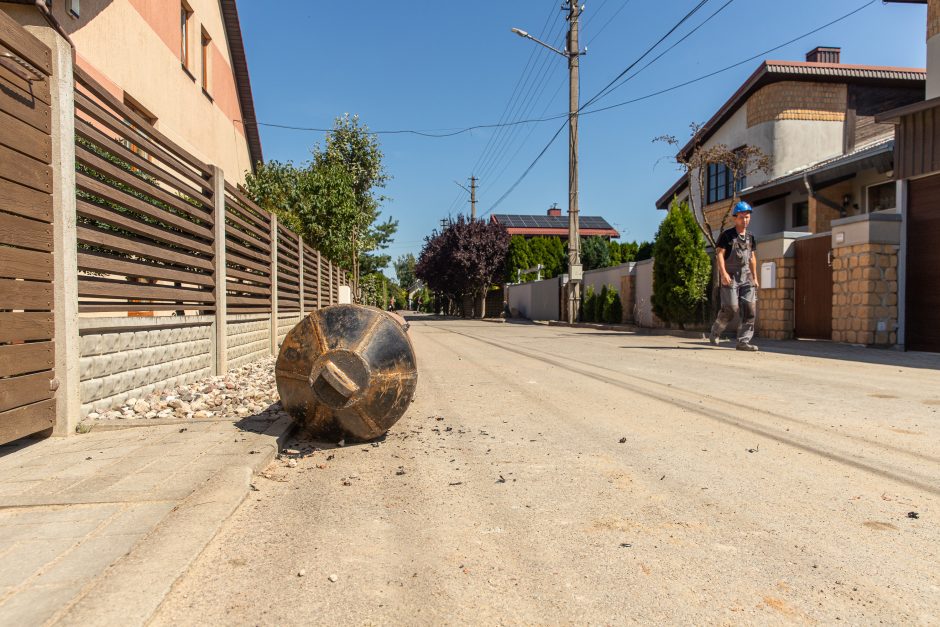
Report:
79,316,214,417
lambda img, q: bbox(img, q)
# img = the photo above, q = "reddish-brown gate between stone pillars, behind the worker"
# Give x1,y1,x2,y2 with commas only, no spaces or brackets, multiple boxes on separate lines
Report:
793,236,832,340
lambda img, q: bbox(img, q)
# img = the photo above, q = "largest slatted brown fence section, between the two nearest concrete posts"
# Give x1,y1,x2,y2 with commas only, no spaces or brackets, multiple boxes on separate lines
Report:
75,68,215,315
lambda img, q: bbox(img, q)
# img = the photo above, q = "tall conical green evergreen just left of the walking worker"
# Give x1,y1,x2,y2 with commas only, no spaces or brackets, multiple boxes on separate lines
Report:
651,201,711,328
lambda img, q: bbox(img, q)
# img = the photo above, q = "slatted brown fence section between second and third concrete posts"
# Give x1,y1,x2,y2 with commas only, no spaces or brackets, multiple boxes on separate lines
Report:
225,183,271,313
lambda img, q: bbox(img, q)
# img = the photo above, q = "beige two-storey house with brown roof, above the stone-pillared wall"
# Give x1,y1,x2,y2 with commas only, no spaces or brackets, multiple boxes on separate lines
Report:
656,47,926,236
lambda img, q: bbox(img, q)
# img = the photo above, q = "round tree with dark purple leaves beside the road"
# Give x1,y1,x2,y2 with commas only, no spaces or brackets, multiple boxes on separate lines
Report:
415,215,509,318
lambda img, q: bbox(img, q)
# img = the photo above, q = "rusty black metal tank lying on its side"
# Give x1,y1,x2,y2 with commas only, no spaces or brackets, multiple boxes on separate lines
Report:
275,305,418,440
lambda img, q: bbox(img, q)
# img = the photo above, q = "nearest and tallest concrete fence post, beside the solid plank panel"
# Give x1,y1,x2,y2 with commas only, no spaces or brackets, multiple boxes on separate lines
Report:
25,26,81,436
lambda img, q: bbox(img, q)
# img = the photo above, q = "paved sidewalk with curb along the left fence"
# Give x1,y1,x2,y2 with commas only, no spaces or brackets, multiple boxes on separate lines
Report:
0,414,292,626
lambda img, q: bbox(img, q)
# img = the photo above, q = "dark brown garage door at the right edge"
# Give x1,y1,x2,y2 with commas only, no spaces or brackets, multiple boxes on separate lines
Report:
904,175,940,352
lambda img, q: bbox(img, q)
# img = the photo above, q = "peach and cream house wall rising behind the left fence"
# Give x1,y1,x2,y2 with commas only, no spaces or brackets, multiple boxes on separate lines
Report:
11,0,251,183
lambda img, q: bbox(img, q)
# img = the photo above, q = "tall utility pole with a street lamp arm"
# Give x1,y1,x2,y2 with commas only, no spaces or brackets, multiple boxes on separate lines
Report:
512,0,584,322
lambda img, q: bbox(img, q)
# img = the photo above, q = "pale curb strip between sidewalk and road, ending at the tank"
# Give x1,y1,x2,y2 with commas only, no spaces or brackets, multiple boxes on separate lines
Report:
50,417,293,627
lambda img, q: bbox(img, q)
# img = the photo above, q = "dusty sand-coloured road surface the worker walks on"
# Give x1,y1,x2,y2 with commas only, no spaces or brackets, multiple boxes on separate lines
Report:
153,321,940,625
